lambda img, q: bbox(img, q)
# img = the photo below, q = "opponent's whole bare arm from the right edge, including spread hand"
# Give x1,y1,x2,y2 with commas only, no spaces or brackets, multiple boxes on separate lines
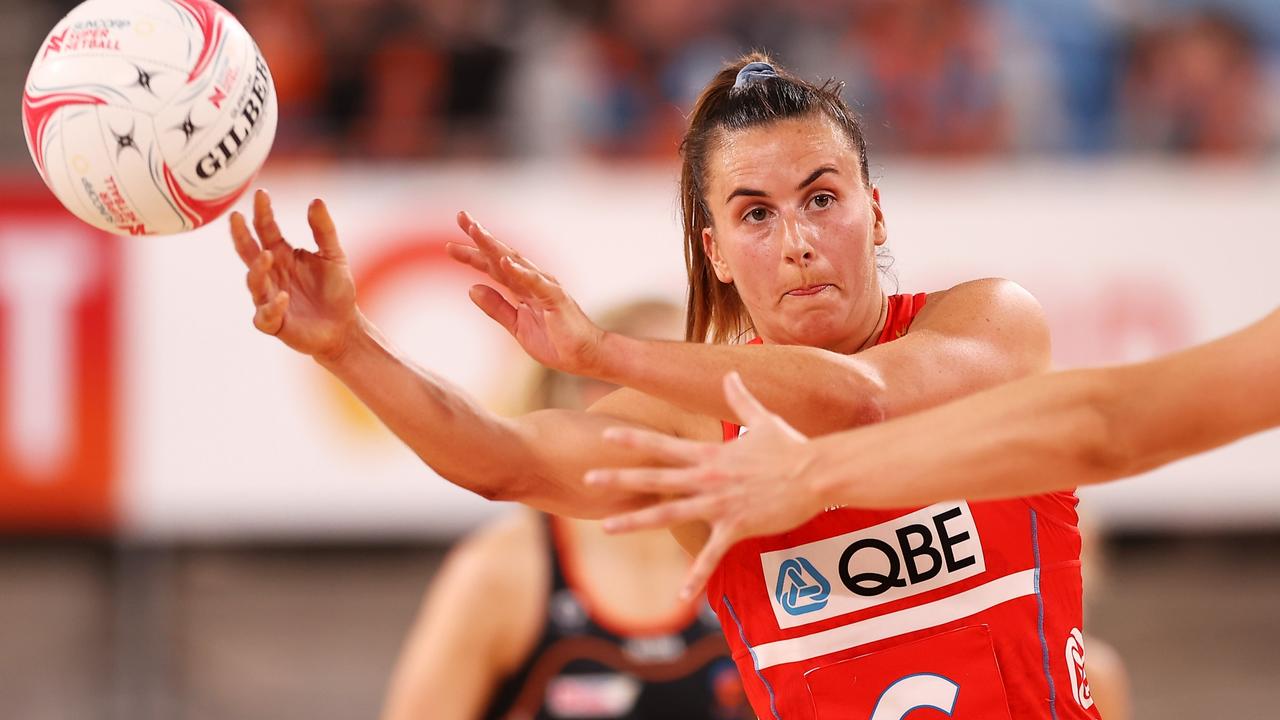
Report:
588,311,1280,591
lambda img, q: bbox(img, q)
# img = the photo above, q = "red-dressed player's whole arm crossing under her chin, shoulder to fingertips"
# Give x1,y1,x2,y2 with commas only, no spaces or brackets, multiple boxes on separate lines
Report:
449,213,1050,434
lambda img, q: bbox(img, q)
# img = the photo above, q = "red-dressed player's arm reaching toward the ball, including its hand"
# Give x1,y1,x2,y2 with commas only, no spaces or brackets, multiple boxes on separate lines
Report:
232,192,711,516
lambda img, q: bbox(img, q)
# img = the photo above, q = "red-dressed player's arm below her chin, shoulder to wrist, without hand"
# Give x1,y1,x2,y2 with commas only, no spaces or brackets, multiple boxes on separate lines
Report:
600,274,1050,436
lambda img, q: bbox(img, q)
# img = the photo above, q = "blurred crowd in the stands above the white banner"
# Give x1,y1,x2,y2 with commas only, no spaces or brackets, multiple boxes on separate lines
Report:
27,0,1280,159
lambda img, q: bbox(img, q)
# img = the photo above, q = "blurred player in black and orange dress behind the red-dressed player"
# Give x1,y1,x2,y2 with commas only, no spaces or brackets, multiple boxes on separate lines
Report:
383,301,754,720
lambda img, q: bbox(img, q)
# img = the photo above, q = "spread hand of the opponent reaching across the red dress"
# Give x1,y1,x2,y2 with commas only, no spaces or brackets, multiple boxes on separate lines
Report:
586,373,822,598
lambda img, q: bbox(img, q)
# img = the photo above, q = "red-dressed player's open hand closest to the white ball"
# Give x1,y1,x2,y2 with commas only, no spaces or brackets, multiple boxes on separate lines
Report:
230,190,360,360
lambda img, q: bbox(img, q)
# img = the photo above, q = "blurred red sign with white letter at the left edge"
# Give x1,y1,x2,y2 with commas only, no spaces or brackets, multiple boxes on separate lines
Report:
0,186,122,532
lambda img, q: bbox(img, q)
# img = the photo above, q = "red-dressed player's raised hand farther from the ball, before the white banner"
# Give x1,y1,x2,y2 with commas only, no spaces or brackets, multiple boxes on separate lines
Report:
445,211,604,377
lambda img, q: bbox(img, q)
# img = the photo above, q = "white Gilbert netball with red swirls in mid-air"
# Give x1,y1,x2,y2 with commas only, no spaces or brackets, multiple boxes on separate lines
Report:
22,0,276,234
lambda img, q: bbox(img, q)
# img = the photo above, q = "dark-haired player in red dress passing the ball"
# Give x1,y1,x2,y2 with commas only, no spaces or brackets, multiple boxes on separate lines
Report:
232,56,1097,720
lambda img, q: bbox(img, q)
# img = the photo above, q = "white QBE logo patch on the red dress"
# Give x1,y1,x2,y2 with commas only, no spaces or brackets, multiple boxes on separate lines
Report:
760,502,987,628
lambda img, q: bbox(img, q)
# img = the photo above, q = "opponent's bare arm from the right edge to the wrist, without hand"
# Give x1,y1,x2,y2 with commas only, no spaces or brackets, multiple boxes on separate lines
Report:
810,311,1280,507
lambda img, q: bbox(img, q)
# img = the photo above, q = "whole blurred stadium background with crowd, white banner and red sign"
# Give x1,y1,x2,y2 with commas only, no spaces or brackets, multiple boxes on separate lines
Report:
0,0,1280,720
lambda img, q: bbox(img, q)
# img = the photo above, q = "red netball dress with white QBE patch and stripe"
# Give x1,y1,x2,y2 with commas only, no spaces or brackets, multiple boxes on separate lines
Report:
707,293,1098,720
